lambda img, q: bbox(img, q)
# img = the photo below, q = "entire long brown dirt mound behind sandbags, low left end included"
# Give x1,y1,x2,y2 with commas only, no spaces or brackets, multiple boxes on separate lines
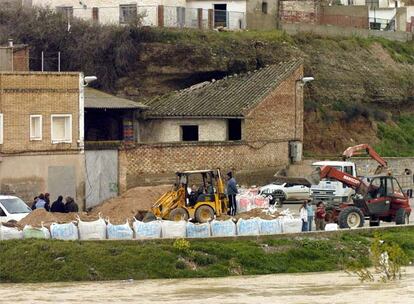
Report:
18,185,171,228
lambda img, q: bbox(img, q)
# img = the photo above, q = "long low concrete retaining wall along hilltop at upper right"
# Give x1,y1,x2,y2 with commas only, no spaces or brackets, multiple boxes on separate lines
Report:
280,23,413,42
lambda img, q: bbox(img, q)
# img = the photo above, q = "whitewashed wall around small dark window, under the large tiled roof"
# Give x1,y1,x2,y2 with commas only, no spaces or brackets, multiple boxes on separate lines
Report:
140,119,227,142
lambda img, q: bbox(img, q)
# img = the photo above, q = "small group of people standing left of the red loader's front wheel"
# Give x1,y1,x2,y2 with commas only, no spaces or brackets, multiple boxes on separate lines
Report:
299,200,326,231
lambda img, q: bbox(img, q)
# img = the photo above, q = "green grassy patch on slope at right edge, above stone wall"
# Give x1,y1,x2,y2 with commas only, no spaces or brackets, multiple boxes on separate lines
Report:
375,115,414,157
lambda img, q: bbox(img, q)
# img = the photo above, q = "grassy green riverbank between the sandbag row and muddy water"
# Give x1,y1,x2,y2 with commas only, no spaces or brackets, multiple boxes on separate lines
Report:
0,226,414,283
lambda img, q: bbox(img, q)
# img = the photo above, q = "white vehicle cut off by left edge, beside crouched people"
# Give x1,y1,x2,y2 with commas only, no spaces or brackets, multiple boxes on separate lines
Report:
0,195,32,223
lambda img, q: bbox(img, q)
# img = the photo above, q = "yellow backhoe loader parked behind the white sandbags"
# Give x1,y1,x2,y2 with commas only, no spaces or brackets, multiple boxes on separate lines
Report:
152,169,228,223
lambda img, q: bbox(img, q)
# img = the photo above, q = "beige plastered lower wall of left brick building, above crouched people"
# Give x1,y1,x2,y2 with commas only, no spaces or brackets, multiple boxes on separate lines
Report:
0,153,85,208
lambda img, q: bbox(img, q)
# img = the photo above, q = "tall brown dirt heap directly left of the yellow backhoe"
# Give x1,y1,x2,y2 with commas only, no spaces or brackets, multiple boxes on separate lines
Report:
88,185,171,224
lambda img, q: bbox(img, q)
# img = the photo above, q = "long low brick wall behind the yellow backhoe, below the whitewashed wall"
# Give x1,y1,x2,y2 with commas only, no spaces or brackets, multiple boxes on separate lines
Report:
119,142,289,193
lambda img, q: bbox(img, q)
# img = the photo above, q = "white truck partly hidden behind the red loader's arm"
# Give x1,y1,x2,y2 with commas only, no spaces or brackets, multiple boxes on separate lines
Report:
311,161,357,205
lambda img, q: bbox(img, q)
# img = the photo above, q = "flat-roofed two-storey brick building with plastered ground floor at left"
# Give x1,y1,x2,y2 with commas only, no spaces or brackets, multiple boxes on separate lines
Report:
0,72,84,206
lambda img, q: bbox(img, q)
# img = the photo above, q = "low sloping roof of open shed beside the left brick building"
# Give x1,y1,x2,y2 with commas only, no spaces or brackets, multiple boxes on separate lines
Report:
85,88,148,109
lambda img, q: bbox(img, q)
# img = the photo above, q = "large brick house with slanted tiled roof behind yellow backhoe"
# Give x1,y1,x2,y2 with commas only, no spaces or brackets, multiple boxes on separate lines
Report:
119,60,303,192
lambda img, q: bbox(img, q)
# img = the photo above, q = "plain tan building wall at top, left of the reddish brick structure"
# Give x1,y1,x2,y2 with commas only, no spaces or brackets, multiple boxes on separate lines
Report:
246,0,279,30
